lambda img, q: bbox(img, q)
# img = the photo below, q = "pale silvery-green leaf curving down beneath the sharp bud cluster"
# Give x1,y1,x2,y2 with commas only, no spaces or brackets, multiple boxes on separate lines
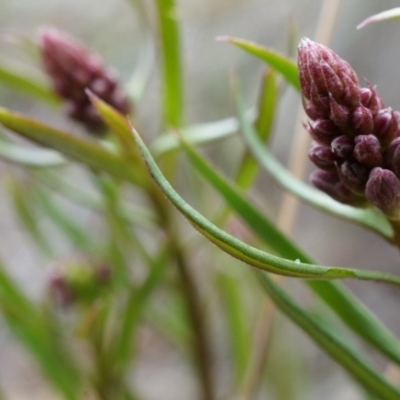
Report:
236,87,394,240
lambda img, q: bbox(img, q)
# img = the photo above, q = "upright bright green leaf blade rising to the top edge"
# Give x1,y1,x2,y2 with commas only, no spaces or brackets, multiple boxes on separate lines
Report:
155,0,184,128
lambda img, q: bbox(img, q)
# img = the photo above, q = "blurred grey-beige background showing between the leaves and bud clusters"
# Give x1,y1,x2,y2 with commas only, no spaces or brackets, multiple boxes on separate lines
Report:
0,0,400,400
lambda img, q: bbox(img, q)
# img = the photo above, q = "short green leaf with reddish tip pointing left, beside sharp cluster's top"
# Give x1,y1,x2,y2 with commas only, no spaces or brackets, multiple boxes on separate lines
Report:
217,36,300,91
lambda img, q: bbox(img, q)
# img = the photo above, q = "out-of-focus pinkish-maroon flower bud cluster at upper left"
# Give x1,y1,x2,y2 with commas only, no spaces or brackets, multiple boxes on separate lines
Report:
40,28,130,133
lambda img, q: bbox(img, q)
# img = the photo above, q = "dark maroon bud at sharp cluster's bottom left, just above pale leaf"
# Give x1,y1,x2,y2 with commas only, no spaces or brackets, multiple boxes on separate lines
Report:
310,171,356,204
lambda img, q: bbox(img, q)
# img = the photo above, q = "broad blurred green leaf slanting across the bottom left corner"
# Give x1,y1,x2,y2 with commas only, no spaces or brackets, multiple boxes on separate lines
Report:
0,266,81,400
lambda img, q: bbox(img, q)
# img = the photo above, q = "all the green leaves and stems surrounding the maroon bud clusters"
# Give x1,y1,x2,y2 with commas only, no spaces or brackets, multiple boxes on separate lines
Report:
0,0,400,400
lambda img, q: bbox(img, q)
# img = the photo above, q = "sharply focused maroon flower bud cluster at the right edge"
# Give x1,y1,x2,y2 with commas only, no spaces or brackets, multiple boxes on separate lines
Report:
298,38,400,219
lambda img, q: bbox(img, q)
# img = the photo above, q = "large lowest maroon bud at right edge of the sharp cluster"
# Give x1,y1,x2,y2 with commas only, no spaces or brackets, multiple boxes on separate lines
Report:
365,167,400,219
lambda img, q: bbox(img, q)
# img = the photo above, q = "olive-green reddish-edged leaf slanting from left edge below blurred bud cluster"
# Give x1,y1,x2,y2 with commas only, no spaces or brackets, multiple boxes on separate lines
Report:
0,108,144,185
